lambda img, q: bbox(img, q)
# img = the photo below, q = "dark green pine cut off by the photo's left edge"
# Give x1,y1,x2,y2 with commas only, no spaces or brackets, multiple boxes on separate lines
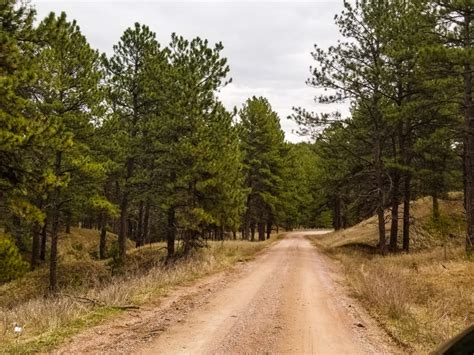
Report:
0,0,50,253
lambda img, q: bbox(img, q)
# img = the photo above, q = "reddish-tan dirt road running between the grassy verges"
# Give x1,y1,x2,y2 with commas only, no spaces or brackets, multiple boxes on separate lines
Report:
57,233,399,354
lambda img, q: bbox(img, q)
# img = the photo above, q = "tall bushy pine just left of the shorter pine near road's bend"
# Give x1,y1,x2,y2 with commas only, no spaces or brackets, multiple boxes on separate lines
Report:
155,34,229,257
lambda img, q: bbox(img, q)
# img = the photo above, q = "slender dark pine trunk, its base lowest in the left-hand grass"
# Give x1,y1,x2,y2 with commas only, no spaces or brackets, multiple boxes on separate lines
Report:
49,152,62,294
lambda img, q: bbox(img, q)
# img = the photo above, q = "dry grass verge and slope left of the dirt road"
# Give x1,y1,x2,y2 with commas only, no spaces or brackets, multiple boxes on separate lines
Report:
0,229,277,353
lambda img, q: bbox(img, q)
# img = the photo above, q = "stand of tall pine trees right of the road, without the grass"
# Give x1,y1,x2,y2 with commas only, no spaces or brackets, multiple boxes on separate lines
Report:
293,0,474,254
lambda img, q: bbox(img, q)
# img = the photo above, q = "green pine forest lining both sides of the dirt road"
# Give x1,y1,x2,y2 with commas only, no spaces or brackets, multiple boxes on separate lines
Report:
0,0,474,291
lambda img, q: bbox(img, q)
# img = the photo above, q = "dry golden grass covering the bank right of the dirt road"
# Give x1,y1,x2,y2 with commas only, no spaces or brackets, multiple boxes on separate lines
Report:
313,199,474,354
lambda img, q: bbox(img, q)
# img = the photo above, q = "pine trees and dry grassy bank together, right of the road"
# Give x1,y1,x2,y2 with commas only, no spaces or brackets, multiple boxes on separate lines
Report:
293,0,474,353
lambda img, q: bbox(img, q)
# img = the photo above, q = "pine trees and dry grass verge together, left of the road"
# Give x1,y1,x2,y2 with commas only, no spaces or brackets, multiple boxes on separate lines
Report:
0,0,320,352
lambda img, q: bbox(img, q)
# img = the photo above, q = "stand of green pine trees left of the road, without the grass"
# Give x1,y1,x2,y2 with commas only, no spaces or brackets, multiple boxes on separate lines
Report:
0,1,322,293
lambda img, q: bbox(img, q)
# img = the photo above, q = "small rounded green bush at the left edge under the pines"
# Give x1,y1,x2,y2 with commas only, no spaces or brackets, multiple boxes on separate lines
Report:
0,238,28,283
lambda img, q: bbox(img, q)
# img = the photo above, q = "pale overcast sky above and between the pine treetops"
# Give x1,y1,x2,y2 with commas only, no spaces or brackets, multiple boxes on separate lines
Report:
31,0,343,142
